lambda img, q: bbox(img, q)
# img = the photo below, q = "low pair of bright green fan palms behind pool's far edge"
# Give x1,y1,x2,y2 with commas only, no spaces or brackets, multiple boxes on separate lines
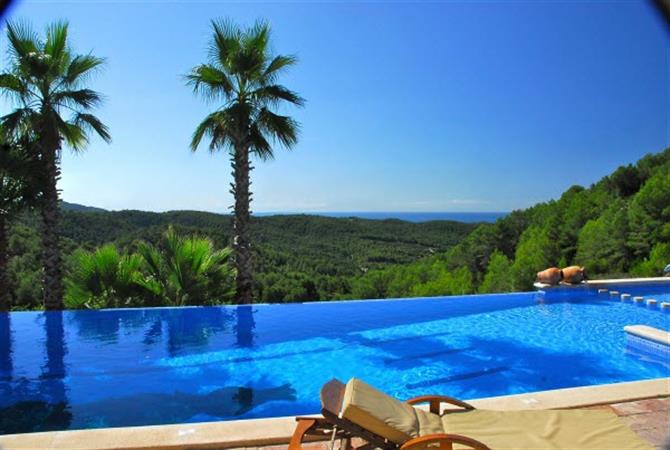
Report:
65,228,235,308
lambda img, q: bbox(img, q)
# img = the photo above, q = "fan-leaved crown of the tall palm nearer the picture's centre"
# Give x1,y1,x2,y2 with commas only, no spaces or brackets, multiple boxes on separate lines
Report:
186,21,304,159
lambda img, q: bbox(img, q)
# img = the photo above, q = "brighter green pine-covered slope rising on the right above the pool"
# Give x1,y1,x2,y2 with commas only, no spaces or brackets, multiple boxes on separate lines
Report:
352,149,670,298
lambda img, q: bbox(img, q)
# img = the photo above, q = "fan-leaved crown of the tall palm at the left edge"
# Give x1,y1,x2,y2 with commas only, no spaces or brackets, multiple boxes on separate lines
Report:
0,22,111,151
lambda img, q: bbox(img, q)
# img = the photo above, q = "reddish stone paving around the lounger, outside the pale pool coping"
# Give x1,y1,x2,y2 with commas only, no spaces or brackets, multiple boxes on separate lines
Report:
233,397,670,450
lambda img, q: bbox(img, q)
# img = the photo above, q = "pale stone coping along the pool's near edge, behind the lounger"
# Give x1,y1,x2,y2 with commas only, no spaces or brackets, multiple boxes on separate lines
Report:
0,377,670,450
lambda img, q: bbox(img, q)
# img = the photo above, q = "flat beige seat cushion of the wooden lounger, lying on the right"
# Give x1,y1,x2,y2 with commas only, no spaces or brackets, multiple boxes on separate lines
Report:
442,409,652,450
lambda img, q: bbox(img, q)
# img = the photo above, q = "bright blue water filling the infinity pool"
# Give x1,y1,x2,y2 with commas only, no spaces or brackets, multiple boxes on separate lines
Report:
0,285,670,433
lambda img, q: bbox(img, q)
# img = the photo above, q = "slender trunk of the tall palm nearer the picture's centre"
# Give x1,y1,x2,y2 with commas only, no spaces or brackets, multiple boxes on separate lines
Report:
230,145,253,304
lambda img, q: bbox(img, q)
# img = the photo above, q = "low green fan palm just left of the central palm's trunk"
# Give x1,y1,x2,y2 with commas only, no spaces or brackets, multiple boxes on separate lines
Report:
137,227,235,306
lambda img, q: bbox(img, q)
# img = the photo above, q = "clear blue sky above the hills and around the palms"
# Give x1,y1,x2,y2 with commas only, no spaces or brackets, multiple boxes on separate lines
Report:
0,0,670,212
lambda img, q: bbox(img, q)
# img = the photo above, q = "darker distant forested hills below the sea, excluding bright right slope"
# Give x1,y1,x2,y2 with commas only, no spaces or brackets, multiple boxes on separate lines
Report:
9,212,476,309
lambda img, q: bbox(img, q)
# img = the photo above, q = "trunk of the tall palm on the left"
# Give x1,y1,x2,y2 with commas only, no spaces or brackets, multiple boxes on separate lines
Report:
41,146,63,310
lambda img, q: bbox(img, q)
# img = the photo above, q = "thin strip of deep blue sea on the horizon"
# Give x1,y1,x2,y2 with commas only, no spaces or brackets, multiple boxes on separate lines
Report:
254,211,509,223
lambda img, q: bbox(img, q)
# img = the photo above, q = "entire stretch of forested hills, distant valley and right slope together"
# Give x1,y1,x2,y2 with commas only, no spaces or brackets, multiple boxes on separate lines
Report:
9,149,670,309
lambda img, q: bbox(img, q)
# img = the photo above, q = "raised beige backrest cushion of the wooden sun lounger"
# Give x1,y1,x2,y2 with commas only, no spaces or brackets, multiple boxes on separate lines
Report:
342,378,419,444
